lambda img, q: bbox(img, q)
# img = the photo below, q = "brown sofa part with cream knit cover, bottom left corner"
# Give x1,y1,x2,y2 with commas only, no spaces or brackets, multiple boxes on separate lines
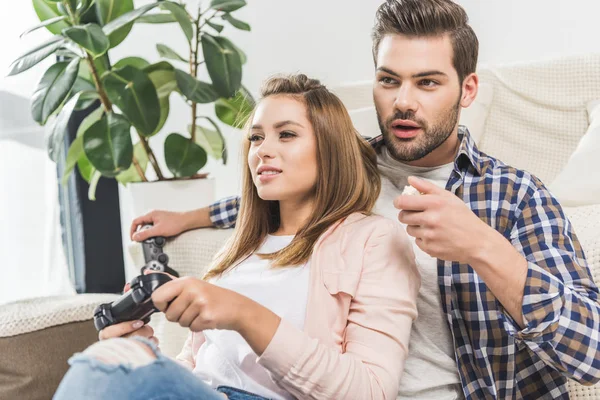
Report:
0,294,117,400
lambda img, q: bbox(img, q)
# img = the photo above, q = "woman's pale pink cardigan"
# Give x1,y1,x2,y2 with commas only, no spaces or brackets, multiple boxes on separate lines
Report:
177,214,421,400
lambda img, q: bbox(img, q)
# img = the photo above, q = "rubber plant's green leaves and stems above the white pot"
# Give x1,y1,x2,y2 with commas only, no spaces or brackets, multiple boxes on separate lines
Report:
9,0,254,203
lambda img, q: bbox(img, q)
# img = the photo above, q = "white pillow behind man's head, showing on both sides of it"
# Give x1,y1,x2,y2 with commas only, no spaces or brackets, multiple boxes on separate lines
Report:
334,83,494,143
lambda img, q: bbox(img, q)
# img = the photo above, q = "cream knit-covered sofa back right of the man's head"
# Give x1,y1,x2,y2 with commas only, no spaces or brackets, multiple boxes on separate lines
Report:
478,54,600,184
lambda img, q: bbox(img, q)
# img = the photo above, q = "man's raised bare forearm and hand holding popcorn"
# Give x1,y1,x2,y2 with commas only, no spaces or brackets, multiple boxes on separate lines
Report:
394,177,528,328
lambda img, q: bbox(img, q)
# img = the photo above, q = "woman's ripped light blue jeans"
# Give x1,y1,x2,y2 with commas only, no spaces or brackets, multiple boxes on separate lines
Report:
53,337,267,400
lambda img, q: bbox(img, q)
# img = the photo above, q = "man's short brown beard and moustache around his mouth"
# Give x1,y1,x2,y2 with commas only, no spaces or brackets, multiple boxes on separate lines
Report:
377,97,460,162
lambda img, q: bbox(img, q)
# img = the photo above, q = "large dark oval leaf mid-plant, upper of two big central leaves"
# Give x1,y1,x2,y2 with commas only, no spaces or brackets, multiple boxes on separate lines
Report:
102,65,160,135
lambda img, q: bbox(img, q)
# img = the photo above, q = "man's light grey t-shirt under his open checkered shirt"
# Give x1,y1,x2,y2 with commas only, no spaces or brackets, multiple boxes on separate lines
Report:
374,147,464,400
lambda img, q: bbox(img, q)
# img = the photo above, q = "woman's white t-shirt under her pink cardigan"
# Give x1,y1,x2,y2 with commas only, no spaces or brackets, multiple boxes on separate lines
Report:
193,235,309,399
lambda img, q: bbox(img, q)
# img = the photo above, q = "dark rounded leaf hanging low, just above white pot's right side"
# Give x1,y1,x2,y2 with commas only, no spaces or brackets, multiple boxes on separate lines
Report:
165,133,207,178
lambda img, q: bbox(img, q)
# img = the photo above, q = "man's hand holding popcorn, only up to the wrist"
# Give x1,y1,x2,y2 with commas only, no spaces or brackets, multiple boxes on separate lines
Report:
394,177,505,264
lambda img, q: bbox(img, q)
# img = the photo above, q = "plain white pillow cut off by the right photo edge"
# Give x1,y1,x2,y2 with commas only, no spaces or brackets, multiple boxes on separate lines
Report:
548,100,600,207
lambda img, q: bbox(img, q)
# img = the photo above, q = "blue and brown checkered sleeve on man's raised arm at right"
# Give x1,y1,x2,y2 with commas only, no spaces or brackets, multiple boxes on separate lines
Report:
507,184,600,384
